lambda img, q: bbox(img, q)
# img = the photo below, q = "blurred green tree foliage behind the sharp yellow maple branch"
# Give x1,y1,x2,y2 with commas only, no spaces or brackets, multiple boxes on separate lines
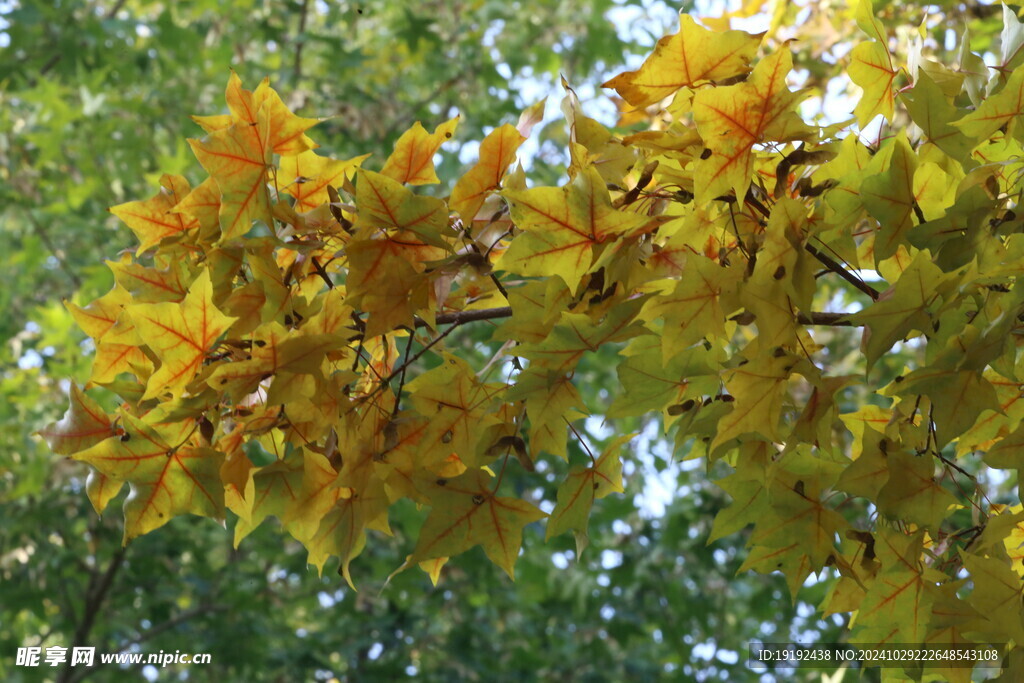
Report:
0,0,999,681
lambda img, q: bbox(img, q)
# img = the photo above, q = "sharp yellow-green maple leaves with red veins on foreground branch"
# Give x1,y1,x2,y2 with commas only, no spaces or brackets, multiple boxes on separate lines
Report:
42,0,1024,681
